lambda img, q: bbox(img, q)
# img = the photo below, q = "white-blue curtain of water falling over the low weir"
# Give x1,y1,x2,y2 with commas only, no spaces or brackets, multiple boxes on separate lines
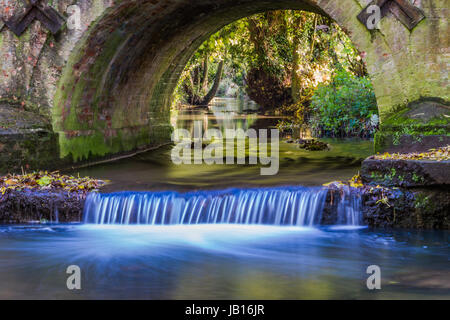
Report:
84,187,360,226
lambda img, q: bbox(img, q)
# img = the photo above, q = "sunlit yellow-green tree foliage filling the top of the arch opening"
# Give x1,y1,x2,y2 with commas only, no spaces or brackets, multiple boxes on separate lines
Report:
177,10,365,107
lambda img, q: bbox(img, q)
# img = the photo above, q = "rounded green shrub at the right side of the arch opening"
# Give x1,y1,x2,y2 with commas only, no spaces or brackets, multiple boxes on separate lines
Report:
310,69,378,137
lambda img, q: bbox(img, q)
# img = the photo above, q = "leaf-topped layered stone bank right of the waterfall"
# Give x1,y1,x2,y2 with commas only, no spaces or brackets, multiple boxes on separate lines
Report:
361,146,450,230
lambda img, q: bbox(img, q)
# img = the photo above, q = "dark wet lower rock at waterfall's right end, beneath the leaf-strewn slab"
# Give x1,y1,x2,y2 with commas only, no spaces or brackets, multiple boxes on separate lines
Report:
322,171,450,230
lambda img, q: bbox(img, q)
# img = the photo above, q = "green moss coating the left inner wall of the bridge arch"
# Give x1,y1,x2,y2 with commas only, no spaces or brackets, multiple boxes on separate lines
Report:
53,19,158,162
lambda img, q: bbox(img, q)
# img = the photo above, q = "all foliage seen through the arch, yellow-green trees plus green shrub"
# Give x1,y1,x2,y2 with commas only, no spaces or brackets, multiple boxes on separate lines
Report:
173,10,377,137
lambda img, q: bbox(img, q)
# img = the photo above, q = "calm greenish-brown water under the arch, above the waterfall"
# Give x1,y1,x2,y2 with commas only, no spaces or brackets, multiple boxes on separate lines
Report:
72,99,373,192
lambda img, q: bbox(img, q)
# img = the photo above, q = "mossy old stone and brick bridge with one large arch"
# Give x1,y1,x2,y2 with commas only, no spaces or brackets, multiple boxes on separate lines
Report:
0,0,450,172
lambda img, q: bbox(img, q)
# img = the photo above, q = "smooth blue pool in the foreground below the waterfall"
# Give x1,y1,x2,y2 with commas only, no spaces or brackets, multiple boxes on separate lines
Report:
0,225,450,299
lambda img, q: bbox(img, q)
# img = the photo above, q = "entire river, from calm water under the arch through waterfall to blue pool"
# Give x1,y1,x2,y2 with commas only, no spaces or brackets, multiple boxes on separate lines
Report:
0,99,450,299
